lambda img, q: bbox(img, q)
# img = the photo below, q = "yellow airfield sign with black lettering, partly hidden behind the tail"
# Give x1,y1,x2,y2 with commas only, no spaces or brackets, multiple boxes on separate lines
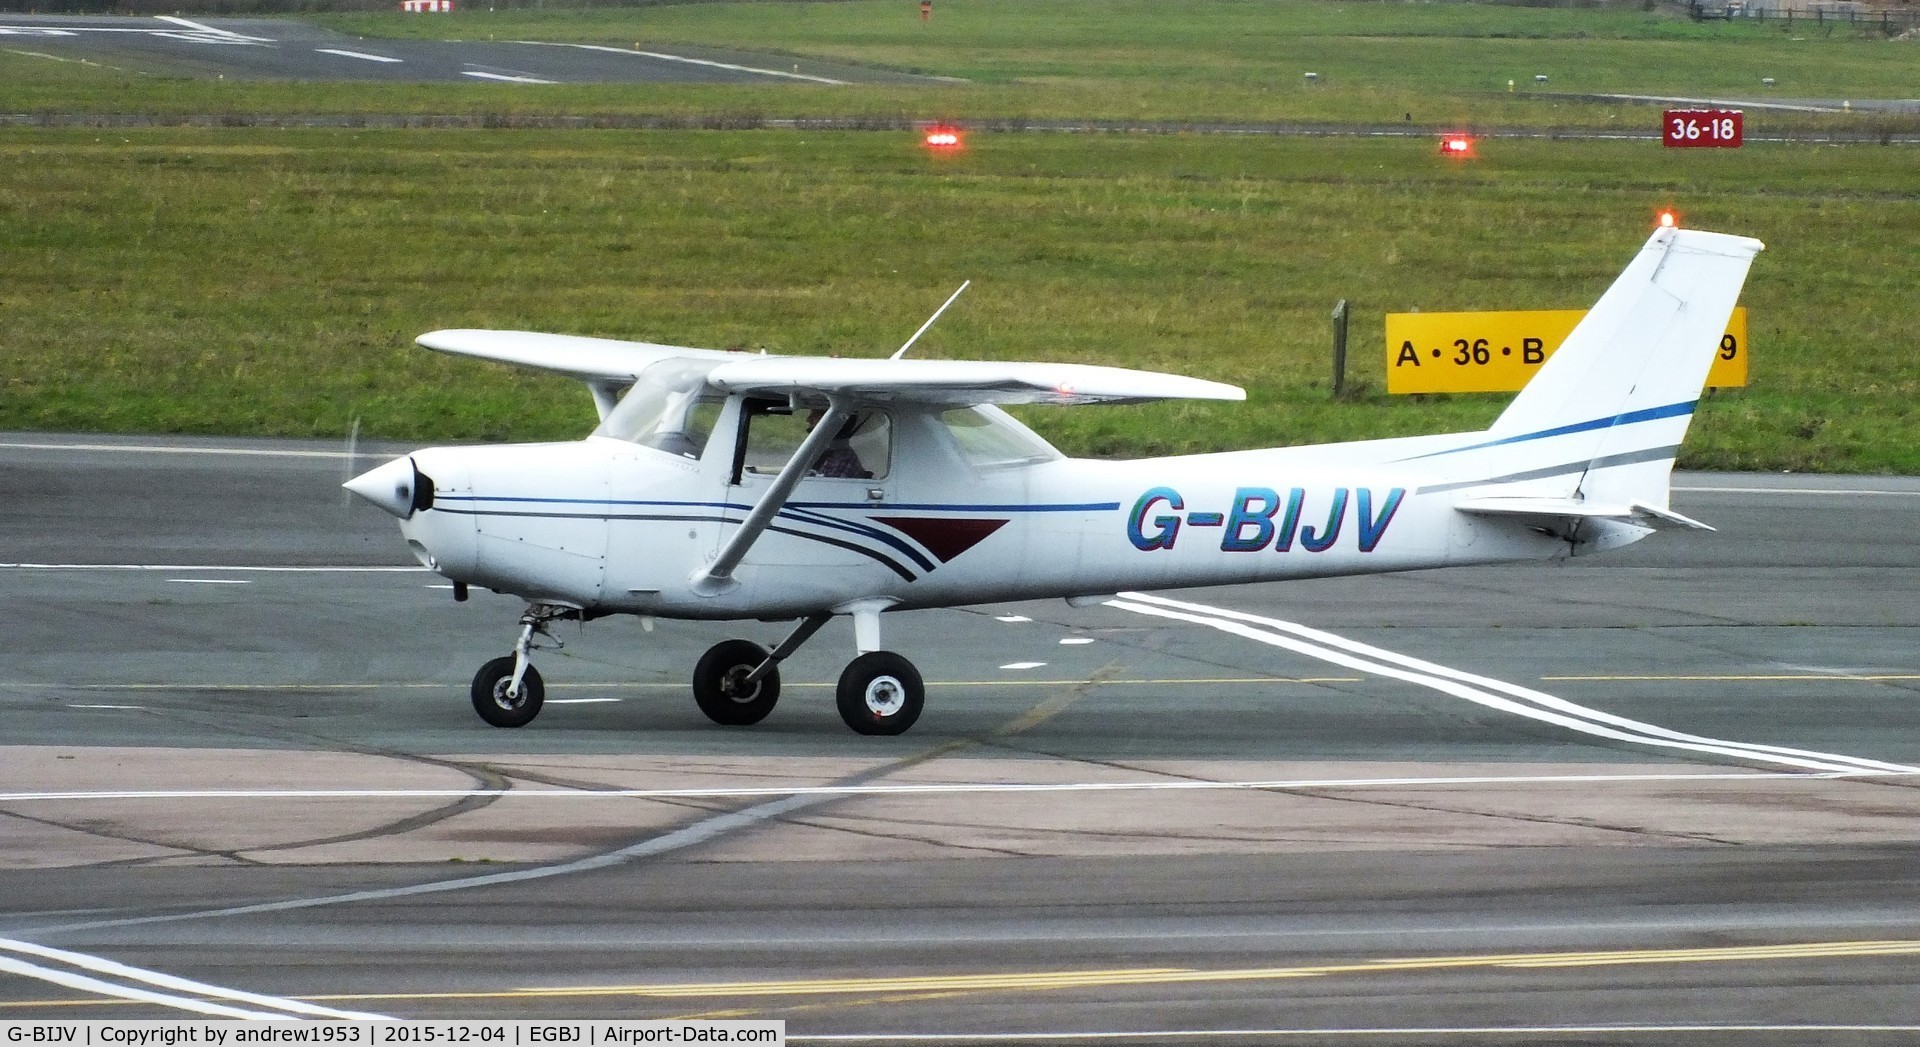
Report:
1386,305,1747,392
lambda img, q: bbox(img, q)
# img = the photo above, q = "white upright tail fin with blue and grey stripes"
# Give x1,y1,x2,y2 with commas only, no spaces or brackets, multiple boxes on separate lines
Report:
1478,229,1763,509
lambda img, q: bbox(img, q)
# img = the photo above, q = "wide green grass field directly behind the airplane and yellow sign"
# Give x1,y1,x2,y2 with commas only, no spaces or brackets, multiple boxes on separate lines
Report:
0,129,1920,471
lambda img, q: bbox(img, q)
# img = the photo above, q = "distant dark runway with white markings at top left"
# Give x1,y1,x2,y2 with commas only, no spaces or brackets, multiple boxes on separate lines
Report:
0,13,935,85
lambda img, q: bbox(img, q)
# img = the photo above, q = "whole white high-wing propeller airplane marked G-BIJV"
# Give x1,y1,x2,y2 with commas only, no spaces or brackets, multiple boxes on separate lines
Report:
346,229,1761,734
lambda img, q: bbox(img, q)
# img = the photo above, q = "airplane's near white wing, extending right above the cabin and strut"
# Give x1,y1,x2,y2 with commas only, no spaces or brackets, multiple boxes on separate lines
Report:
707,355,1246,407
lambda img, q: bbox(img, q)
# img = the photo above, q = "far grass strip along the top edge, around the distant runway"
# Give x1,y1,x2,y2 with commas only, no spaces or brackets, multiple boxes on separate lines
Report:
11,0,1920,133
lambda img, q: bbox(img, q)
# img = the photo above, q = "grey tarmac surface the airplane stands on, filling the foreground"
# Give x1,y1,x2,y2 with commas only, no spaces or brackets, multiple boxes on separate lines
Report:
0,434,1920,1043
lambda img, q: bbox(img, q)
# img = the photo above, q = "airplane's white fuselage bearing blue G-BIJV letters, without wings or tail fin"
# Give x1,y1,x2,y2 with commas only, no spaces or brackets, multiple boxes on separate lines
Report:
385,398,1569,619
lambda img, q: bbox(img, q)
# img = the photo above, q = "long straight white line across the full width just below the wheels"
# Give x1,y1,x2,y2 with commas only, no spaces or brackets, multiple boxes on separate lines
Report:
0,770,1920,803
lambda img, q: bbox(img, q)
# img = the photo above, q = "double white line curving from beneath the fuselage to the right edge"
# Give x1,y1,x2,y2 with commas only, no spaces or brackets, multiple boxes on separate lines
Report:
1106,592,1920,774
